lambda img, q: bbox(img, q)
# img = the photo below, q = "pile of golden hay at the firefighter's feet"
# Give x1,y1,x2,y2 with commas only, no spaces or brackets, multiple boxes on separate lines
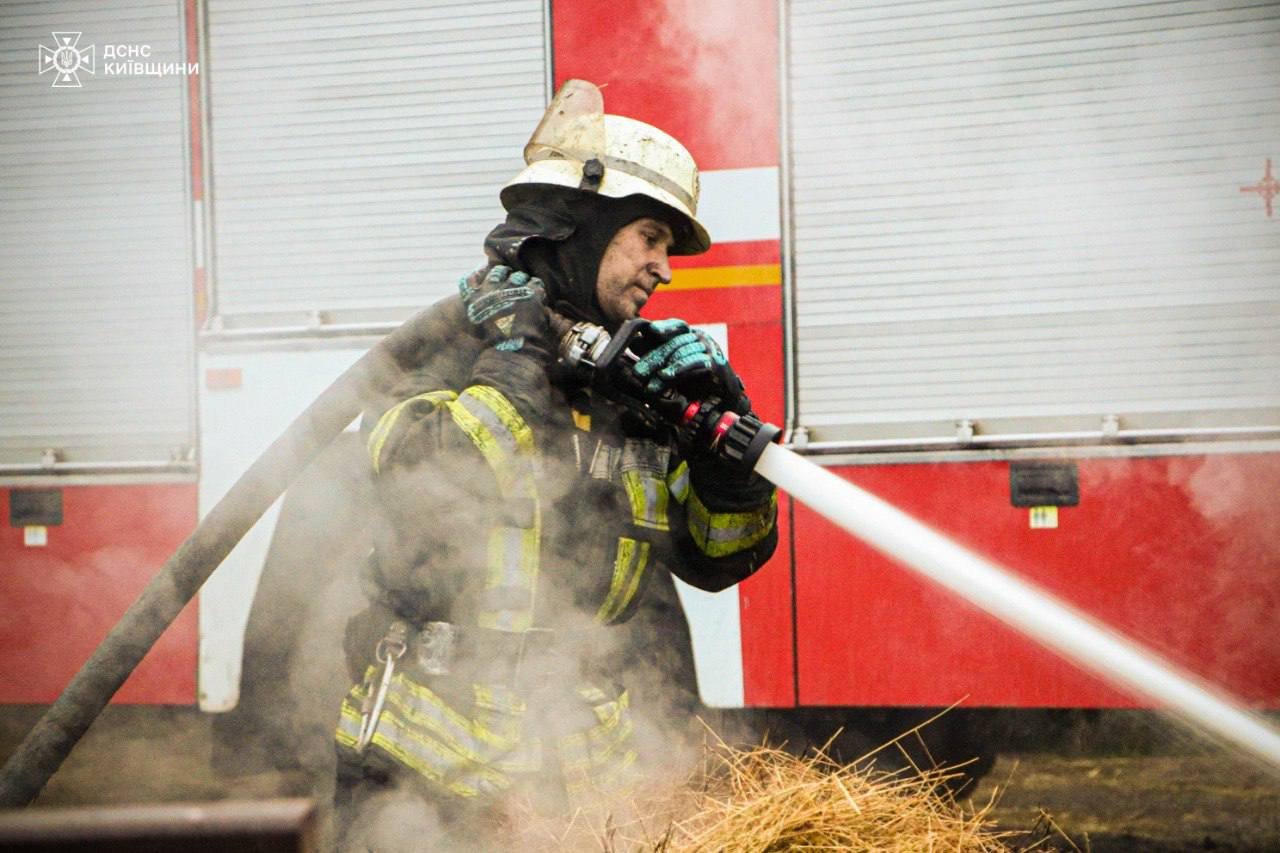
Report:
526,744,1009,853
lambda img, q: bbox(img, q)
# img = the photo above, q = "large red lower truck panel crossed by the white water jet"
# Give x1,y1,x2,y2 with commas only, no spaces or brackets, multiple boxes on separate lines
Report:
788,455,1280,707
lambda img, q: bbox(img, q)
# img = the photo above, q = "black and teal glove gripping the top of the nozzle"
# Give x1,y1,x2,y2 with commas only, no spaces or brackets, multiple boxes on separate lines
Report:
634,319,751,415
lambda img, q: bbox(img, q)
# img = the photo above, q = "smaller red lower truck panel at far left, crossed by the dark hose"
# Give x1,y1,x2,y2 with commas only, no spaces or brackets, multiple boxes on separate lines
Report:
0,484,198,704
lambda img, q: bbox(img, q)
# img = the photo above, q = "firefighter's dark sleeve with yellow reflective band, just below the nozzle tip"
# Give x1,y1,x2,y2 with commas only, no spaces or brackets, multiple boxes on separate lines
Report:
667,440,778,592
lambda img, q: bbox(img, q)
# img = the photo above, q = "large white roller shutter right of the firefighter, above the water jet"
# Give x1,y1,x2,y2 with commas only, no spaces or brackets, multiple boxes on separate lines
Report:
788,0,1280,442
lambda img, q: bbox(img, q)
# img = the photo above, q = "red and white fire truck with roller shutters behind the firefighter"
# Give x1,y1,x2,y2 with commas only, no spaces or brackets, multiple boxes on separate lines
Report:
0,0,1280,768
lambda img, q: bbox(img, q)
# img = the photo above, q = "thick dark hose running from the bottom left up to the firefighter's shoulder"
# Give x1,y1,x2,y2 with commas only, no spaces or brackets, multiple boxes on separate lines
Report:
0,311,442,808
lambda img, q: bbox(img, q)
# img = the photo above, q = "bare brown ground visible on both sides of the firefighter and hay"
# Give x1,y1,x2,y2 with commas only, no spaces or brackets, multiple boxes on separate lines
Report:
0,707,1280,853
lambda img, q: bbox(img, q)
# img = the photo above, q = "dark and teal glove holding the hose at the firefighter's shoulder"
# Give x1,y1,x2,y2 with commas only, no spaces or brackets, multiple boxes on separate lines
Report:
458,258,549,356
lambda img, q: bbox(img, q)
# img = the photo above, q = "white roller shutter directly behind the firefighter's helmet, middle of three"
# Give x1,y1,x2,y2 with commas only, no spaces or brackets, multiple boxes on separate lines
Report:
207,0,547,328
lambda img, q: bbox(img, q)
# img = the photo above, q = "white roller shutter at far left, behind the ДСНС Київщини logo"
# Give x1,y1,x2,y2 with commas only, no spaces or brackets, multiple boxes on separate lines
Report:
0,0,195,473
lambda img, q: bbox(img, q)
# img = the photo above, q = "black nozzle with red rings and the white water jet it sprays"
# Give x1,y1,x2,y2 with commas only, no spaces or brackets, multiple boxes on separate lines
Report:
561,320,1280,774
